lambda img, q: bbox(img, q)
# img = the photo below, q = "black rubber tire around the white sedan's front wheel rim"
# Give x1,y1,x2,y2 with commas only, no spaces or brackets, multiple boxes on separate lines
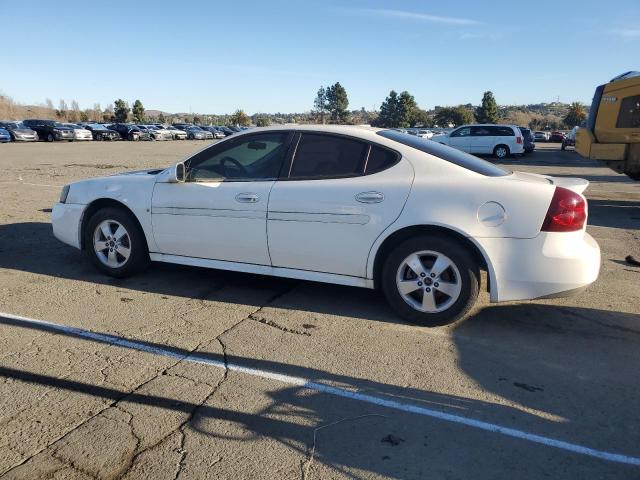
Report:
83,207,149,278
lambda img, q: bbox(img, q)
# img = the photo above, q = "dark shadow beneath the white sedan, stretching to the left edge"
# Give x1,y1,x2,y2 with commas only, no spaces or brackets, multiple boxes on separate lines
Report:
0,222,402,323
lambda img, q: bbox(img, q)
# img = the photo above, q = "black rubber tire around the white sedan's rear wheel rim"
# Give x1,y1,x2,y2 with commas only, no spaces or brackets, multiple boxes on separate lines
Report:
380,235,480,326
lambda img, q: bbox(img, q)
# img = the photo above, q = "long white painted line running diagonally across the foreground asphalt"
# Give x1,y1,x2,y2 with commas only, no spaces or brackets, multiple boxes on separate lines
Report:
0,312,640,466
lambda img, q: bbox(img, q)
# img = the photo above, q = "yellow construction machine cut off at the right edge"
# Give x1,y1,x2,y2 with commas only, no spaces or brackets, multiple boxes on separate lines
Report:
576,72,640,180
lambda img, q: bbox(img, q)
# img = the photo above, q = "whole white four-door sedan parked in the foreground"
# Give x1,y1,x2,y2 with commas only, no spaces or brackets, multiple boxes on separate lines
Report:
52,126,600,325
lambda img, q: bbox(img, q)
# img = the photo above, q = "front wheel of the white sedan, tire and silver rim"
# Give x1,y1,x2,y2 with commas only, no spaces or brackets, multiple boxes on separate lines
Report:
84,208,149,278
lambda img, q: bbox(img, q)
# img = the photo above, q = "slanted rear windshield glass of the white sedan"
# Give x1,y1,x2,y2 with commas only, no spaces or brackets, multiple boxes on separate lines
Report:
378,130,511,177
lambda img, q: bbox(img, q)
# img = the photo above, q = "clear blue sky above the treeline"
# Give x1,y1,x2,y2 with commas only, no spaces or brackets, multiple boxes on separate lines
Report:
0,0,640,114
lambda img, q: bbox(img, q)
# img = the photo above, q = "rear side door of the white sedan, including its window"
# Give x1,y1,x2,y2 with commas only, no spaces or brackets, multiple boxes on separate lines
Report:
267,132,413,277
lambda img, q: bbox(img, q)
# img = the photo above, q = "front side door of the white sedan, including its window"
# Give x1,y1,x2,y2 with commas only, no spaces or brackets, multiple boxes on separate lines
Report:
151,131,292,265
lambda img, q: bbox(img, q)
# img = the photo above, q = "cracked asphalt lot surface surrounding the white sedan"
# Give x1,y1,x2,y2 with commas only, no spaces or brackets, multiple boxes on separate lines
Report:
0,138,640,479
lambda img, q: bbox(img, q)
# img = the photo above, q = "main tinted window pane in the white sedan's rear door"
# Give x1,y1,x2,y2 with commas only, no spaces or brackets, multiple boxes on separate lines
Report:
289,133,369,179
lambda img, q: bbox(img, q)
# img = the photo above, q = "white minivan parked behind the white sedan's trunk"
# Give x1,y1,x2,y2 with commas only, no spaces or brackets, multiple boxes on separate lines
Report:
431,124,524,159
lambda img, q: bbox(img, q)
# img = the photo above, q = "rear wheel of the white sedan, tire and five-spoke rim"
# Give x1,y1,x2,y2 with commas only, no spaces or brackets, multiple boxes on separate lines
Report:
381,235,480,326
